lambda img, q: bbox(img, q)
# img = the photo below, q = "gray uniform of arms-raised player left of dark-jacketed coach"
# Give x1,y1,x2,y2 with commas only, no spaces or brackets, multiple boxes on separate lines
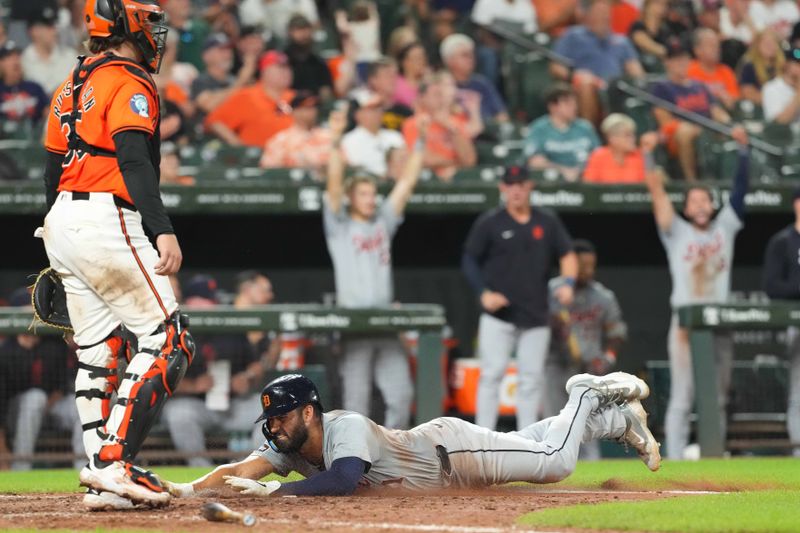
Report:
323,196,414,428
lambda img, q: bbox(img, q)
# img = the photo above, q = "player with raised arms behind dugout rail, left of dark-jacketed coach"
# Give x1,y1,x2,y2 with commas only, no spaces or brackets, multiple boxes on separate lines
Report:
322,111,430,429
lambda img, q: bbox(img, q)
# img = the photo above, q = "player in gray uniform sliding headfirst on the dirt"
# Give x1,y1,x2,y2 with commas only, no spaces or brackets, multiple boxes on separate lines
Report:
164,372,661,497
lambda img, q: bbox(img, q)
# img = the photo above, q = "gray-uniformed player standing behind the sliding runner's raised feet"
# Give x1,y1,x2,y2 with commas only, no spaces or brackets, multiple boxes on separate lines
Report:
546,239,628,460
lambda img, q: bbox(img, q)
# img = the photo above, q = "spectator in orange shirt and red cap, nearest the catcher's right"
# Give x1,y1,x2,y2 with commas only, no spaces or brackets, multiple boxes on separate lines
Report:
205,50,294,148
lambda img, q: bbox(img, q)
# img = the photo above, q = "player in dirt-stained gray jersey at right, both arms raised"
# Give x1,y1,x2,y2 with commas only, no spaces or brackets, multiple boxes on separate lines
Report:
646,127,750,459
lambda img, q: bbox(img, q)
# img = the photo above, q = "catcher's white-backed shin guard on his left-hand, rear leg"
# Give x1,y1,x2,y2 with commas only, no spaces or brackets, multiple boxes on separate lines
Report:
75,330,130,457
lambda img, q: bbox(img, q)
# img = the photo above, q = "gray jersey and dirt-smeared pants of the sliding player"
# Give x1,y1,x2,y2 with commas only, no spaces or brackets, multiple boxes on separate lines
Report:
251,387,626,490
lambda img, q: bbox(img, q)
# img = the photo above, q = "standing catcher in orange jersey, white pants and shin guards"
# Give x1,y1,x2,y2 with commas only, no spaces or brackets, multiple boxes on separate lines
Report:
41,0,194,509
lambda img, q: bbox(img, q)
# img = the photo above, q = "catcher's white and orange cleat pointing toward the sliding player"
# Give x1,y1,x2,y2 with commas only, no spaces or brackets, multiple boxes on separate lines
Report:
78,460,170,507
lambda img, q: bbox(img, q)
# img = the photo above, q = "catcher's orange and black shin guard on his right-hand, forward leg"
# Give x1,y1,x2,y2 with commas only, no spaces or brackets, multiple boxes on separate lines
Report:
98,311,194,462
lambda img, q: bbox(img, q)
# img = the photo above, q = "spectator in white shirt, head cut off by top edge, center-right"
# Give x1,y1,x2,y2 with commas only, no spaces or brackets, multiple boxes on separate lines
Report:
470,0,537,87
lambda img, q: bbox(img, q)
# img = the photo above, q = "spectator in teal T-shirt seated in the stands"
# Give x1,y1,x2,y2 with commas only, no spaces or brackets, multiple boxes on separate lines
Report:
525,83,600,181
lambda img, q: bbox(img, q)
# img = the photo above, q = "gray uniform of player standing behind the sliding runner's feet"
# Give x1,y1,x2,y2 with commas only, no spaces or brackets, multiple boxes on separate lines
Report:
546,278,628,460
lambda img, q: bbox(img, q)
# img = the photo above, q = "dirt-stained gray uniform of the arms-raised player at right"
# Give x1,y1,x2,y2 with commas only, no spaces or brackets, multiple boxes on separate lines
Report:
659,203,742,459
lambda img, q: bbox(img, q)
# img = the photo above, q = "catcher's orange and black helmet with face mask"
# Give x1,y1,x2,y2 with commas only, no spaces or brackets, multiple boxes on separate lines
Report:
84,0,167,74
